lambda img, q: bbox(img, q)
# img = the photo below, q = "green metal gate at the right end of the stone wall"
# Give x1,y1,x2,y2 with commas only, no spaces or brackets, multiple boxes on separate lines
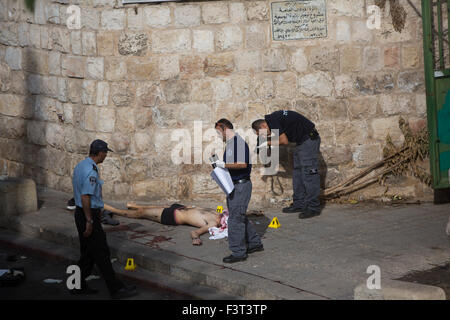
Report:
422,0,450,189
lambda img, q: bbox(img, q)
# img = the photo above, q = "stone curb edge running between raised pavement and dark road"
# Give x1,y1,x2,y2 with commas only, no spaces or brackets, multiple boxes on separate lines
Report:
1,220,329,300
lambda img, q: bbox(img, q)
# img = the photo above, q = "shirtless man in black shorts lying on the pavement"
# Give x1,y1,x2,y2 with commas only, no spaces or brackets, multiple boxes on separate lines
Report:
104,203,222,246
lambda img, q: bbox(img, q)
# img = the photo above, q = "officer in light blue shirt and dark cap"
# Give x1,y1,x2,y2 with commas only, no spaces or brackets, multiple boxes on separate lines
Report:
72,140,137,299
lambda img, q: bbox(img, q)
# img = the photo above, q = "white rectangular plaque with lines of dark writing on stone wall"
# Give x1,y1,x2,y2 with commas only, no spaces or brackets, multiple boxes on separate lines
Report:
271,0,327,41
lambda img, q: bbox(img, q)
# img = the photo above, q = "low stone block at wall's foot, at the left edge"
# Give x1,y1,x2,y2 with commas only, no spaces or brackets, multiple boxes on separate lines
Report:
0,177,38,220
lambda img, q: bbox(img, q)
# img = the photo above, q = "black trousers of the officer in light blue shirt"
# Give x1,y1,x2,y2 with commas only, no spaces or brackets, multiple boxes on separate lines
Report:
75,207,124,294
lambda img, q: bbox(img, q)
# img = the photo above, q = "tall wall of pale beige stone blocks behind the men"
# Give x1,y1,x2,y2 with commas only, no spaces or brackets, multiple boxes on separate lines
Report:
0,0,431,206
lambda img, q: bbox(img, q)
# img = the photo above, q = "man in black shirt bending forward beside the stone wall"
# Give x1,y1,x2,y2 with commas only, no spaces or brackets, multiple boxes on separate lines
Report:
252,110,321,219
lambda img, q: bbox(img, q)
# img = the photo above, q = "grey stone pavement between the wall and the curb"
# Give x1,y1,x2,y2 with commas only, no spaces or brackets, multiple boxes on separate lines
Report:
0,190,450,300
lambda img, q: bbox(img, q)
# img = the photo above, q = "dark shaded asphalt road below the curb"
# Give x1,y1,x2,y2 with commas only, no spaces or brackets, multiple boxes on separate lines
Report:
0,245,192,300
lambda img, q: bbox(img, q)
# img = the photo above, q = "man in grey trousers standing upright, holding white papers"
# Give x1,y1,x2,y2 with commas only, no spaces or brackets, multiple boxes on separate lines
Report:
214,119,264,263
